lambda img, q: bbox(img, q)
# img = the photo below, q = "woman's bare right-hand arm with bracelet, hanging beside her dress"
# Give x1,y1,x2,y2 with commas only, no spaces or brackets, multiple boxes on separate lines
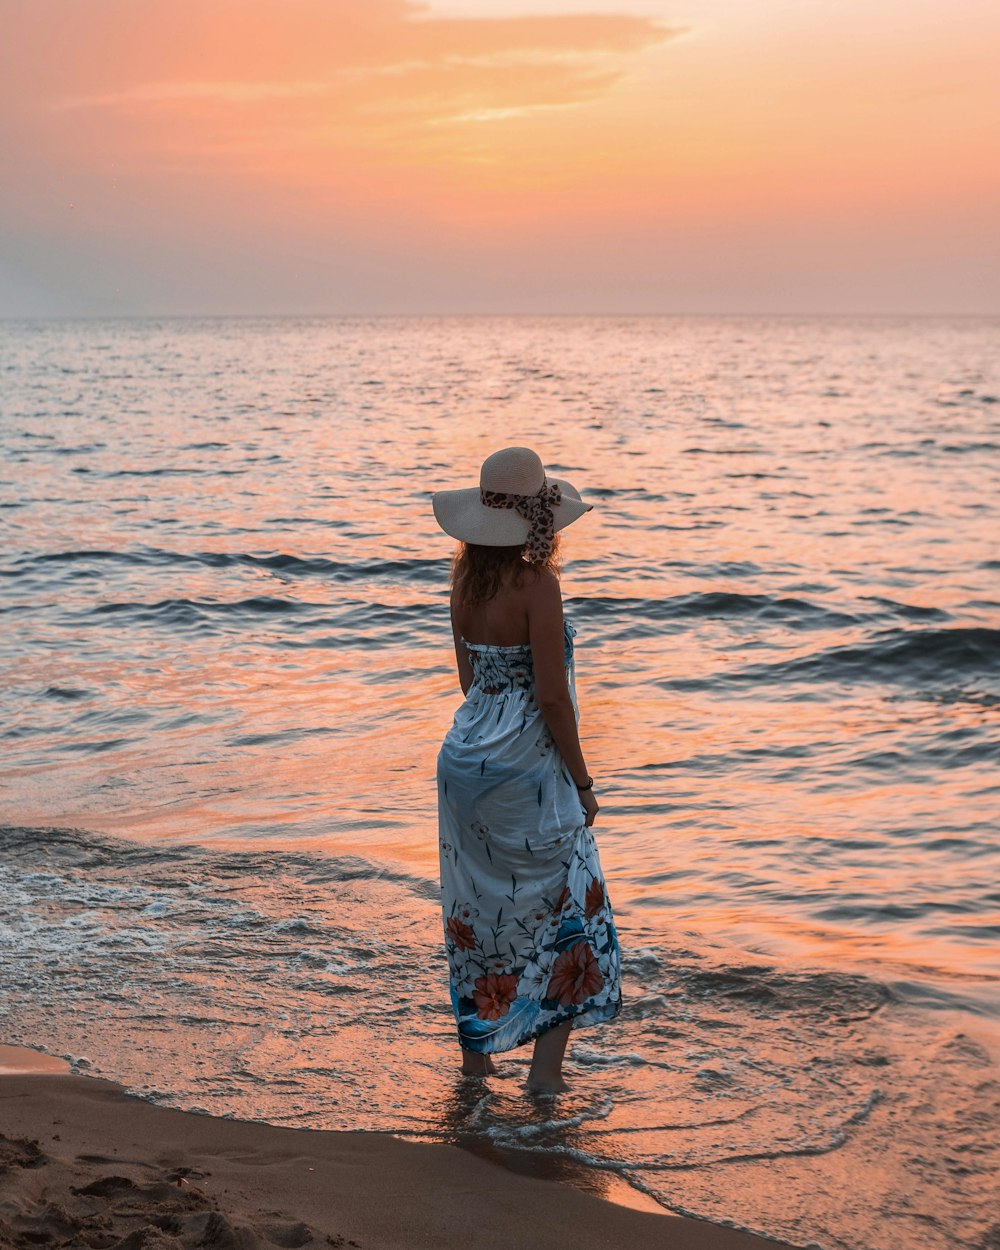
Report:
526,573,598,825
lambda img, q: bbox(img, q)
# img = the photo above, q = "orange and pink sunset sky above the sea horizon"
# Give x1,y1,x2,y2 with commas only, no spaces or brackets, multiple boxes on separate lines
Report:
0,0,1000,316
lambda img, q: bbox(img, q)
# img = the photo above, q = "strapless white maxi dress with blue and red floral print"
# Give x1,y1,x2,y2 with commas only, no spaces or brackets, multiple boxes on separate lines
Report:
438,623,621,1054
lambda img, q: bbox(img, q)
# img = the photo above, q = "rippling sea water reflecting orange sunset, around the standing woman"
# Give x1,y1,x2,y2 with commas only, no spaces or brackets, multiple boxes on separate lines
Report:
0,318,1000,1250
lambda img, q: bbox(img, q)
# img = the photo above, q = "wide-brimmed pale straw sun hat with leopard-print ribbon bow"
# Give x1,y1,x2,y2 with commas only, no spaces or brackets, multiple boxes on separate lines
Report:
433,448,594,560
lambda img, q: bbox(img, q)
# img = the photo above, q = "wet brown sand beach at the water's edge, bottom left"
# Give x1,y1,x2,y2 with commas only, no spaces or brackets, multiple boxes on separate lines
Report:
0,1046,789,1250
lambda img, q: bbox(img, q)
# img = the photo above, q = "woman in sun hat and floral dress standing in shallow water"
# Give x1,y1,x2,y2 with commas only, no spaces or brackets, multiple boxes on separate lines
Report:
434,448,621,1093
